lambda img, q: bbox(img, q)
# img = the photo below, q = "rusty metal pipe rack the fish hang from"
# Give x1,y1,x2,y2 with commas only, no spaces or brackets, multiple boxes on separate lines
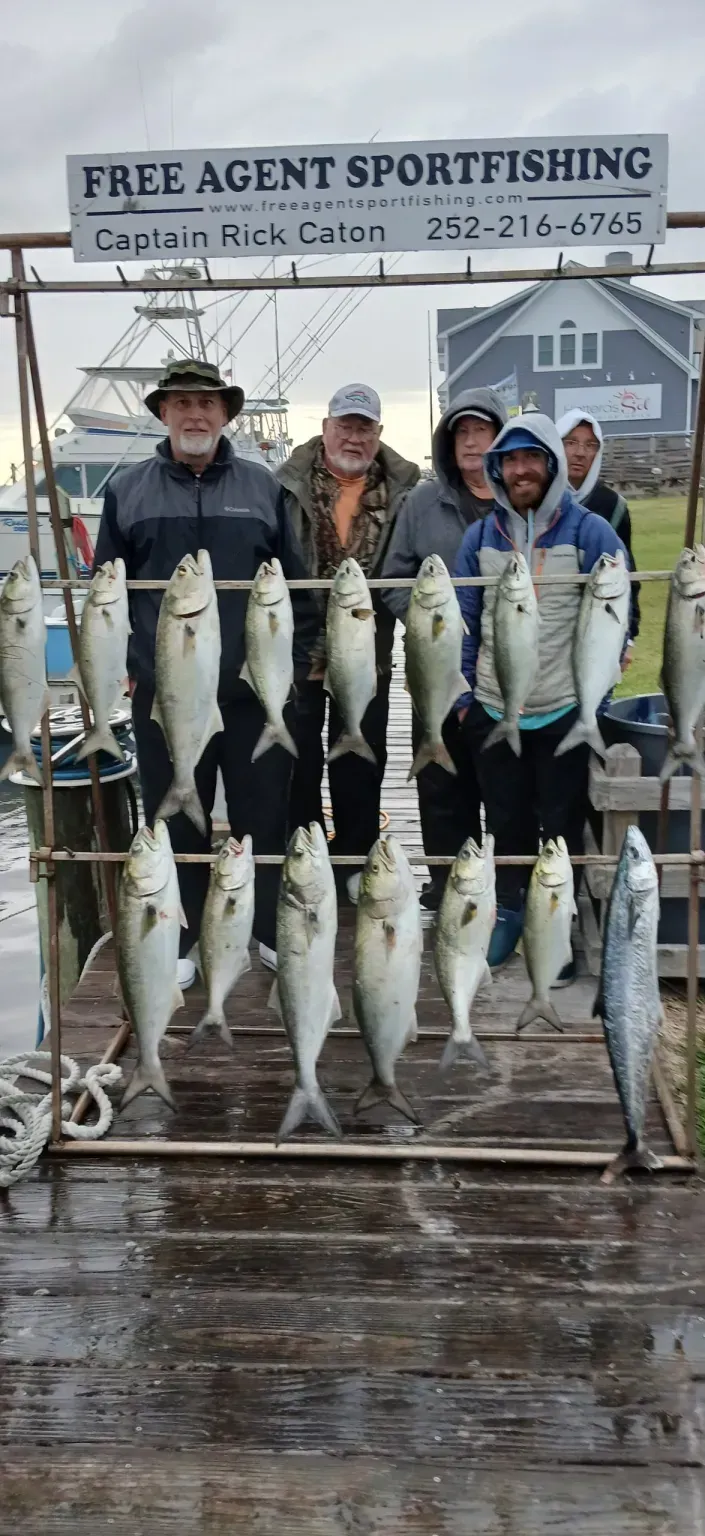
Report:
0,227,705,1172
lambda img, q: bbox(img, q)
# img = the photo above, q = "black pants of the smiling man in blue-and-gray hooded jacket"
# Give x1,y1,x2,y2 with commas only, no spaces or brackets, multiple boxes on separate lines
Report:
464,702,590,909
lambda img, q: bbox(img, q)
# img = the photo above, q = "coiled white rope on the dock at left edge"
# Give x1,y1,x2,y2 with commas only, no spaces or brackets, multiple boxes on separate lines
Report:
0,934,123,1189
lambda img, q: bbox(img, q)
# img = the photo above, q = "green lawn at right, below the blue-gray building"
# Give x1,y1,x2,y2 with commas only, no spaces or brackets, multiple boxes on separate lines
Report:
616,496,694,699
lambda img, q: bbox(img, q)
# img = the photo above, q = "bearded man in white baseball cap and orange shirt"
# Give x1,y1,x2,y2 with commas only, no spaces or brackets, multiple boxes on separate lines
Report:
276,384,419,902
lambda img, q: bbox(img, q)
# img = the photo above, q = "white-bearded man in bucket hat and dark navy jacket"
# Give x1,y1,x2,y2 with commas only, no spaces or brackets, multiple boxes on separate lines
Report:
95,358,318,986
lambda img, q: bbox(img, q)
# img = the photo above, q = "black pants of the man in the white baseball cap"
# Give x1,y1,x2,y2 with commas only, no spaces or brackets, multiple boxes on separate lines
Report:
289,674,390,885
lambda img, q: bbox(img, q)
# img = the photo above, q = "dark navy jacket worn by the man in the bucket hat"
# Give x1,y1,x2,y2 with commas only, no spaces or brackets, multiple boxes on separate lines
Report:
95,438,318,703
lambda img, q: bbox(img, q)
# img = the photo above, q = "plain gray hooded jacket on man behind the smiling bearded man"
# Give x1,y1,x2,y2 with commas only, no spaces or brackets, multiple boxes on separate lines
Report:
382,389,507,622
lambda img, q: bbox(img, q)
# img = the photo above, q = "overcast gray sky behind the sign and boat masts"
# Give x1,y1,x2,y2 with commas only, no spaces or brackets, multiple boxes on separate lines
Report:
0,0,705,475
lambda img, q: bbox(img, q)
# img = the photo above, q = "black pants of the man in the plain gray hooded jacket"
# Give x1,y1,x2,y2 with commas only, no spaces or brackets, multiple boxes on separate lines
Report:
412,710,482,885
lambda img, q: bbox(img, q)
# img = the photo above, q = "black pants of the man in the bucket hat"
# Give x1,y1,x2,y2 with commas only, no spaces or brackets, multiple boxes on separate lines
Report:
132,685,293,955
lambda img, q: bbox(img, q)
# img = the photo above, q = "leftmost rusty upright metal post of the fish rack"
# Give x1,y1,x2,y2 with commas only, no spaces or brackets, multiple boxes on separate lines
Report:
12,250,61,1141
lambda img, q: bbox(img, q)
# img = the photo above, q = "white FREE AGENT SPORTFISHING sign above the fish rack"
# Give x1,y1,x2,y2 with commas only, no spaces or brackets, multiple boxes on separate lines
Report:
68,134,668,261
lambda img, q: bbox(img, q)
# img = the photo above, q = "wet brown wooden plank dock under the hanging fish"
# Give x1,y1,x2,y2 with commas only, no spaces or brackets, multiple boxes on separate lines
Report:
0,666,705,1536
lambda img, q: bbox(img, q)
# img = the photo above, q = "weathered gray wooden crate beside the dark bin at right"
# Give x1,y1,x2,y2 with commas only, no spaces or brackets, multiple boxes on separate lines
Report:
579,742,705,977
